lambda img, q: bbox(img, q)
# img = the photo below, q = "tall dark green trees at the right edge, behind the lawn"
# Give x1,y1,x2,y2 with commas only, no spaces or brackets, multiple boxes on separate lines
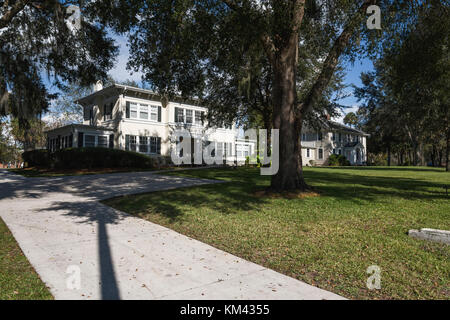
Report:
355,1,450,167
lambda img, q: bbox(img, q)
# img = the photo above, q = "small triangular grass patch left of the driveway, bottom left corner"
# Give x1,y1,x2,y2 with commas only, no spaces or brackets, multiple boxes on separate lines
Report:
0,218,53,300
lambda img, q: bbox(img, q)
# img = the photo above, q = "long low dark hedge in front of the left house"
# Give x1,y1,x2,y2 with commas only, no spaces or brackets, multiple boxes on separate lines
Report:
23,148,161,169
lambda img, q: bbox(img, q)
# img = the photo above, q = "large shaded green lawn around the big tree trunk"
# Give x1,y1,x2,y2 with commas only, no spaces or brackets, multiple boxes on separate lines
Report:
105,167,450,299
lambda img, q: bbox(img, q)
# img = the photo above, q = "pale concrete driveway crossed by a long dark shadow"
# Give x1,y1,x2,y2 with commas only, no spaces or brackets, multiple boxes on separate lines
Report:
0,170,341,300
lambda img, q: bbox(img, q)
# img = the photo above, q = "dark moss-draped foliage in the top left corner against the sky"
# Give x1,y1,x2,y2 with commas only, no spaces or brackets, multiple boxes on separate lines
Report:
0,0,117,119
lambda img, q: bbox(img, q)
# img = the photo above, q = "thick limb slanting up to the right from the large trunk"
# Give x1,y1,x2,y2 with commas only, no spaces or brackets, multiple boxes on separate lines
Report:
298,0,377,115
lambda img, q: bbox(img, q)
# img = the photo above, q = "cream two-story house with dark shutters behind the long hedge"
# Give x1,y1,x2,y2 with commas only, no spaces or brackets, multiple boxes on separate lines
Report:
47,82,255,163
